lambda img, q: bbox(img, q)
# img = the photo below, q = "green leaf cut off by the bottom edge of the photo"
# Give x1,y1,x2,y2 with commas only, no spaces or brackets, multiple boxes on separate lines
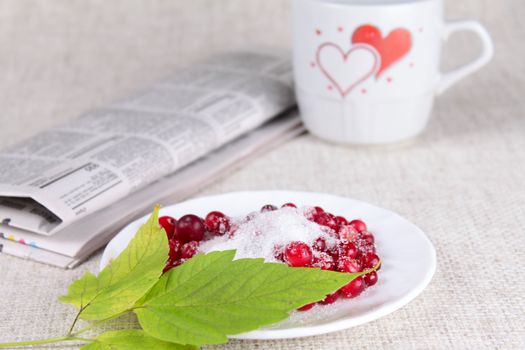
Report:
81,329,197,350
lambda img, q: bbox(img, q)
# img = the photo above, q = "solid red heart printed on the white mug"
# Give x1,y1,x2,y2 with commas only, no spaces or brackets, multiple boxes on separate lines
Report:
351,24,412,78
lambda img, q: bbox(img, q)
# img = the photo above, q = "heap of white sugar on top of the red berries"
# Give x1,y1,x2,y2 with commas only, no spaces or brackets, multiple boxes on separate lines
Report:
199,207,336,262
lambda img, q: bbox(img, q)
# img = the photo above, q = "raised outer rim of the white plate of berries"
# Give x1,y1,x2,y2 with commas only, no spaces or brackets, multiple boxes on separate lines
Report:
99,190,437,340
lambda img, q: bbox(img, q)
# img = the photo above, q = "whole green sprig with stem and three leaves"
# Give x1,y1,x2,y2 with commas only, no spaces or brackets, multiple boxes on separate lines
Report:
0,206,377,350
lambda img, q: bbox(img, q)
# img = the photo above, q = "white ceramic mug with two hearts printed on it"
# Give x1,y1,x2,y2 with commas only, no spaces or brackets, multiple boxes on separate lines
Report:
293,0,493,144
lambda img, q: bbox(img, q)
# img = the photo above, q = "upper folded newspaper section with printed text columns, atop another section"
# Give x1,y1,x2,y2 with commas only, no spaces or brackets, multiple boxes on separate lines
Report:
0,52,295,235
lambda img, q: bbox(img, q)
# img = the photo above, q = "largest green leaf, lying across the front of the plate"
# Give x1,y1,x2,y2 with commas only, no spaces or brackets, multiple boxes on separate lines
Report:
134,251,363,345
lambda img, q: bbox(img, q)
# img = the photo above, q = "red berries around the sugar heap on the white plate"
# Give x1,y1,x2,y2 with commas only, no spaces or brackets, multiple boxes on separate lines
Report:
159,203,380,311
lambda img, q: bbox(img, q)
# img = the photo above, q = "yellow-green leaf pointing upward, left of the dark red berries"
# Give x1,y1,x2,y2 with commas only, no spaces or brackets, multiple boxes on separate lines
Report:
59,206,169,320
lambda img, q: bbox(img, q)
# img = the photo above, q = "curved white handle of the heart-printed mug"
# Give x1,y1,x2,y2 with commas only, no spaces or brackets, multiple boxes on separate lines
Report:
437,21,494,95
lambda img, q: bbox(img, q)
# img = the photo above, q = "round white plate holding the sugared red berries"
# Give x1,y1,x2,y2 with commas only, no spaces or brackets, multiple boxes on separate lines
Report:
100,191,436,339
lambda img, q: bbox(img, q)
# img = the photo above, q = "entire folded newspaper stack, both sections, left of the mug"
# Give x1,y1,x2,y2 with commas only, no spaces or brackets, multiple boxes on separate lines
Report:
0,52,303,268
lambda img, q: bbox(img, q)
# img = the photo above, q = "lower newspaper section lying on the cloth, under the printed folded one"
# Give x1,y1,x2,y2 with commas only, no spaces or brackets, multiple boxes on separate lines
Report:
0,110,304,268
